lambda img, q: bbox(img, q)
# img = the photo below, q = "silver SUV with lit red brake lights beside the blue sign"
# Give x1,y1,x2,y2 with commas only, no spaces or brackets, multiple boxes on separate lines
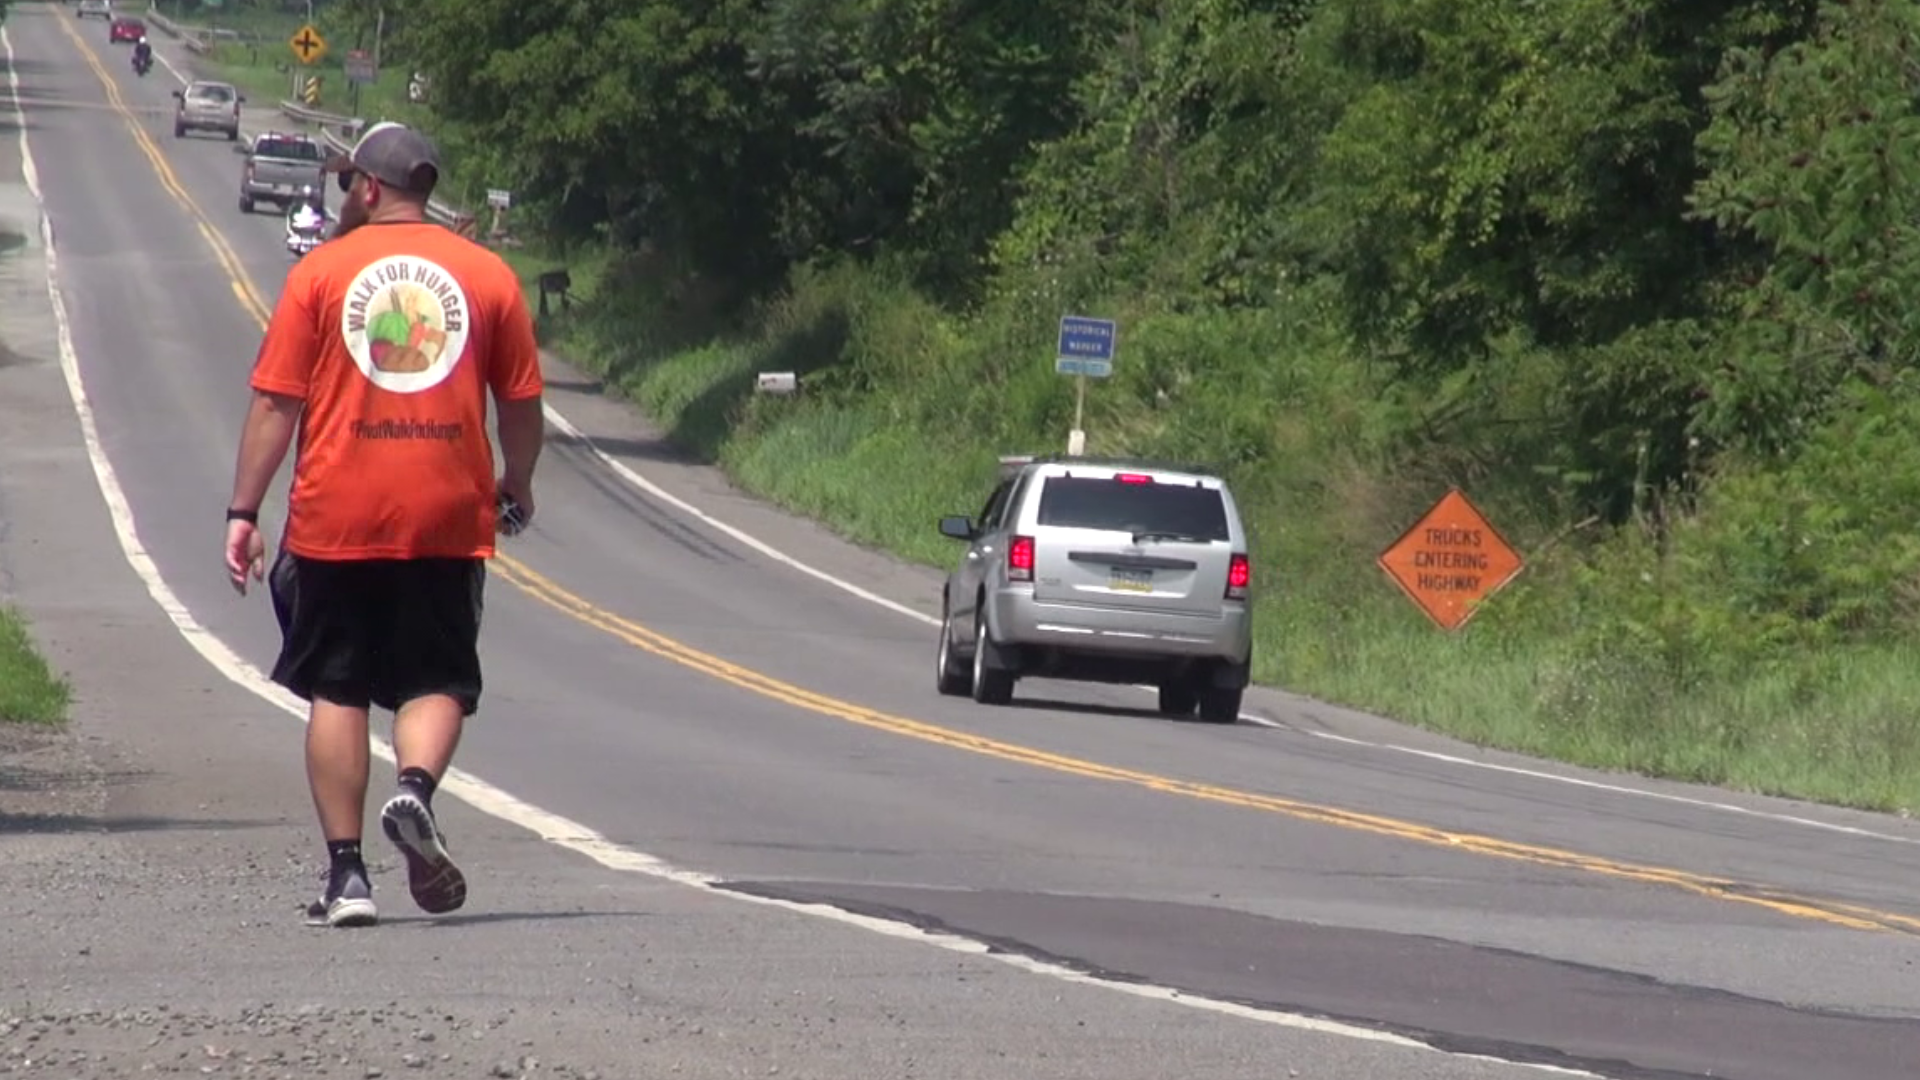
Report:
935,449,1254,724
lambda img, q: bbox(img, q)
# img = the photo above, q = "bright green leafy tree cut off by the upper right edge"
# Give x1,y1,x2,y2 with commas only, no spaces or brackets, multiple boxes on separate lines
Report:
1697,0,1920,450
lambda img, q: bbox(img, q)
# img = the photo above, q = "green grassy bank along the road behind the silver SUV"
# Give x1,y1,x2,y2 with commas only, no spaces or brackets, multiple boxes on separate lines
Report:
513,254,1920,811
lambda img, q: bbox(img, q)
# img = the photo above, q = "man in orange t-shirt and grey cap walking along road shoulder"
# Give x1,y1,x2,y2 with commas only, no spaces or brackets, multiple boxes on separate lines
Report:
227,123,543,926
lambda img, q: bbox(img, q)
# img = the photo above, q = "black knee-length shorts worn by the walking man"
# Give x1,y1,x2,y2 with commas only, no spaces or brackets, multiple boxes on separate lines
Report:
267,552,486,715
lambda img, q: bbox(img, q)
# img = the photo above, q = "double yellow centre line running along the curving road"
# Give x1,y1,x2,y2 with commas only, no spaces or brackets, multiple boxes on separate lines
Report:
48,15,1920,934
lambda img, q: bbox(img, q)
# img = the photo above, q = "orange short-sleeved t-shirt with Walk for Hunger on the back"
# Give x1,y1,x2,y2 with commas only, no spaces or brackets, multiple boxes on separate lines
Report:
252,223,543,559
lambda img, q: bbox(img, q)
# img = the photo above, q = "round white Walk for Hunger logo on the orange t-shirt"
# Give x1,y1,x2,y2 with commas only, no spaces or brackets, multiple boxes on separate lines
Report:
340,256,467,394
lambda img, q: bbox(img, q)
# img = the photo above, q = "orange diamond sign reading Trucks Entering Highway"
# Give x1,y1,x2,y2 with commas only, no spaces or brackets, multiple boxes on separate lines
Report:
1379,488,1523,630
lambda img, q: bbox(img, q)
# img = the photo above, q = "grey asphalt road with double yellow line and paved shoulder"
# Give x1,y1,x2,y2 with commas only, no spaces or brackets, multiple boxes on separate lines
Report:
0,4,1920,1080
